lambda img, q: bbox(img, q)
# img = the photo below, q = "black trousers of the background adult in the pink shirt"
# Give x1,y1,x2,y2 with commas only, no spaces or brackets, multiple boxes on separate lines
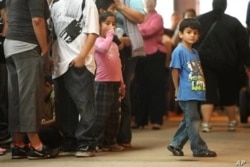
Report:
135,52,167,126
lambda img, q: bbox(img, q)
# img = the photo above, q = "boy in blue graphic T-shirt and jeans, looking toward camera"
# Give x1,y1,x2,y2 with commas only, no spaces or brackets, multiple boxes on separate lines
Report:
167,18,217,157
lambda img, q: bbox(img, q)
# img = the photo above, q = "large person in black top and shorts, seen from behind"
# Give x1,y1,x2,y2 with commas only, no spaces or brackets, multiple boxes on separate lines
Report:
194,0,250,132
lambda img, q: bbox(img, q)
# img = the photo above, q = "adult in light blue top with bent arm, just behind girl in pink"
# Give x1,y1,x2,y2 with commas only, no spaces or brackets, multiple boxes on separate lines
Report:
114,0,146,147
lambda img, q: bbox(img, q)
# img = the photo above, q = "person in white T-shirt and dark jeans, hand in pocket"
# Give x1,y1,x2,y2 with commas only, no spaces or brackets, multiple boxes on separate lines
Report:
50,0,99,157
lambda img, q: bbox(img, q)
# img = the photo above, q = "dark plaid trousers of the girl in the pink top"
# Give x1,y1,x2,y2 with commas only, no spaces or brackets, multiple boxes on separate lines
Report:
94,82,120,146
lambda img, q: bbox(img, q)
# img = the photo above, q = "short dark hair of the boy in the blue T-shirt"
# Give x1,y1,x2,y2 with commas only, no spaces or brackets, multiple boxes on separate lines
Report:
179,18,201,32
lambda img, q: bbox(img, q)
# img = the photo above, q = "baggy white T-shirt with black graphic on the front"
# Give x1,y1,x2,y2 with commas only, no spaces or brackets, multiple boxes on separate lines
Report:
50,0,99,78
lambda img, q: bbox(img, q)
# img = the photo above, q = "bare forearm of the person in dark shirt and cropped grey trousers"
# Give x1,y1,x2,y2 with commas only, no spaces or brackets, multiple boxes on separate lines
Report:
32,17,48,55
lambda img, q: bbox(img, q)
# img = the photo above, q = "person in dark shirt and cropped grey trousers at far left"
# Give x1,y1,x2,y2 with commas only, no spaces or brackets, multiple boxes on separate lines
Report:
4,0,57,159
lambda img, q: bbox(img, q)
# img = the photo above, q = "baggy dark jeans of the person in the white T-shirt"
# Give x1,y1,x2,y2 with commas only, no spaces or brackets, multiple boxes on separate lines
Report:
54,67,95,150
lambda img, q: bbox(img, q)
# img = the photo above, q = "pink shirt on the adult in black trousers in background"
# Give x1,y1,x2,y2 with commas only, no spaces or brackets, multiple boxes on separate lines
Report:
138,11,166,55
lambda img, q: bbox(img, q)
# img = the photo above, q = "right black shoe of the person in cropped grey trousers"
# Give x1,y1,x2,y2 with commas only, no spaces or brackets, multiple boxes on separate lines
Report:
27,145,59,160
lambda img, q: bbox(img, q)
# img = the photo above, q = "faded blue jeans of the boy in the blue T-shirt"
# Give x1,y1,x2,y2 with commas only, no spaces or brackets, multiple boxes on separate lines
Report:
170,101,208,154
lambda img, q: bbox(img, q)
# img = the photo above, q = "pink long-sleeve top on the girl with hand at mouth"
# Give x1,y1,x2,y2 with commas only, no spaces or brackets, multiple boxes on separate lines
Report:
94,30,125,86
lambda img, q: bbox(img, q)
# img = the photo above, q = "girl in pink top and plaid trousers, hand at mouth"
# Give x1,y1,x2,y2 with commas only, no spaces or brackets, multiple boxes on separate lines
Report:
94,11,125,151
